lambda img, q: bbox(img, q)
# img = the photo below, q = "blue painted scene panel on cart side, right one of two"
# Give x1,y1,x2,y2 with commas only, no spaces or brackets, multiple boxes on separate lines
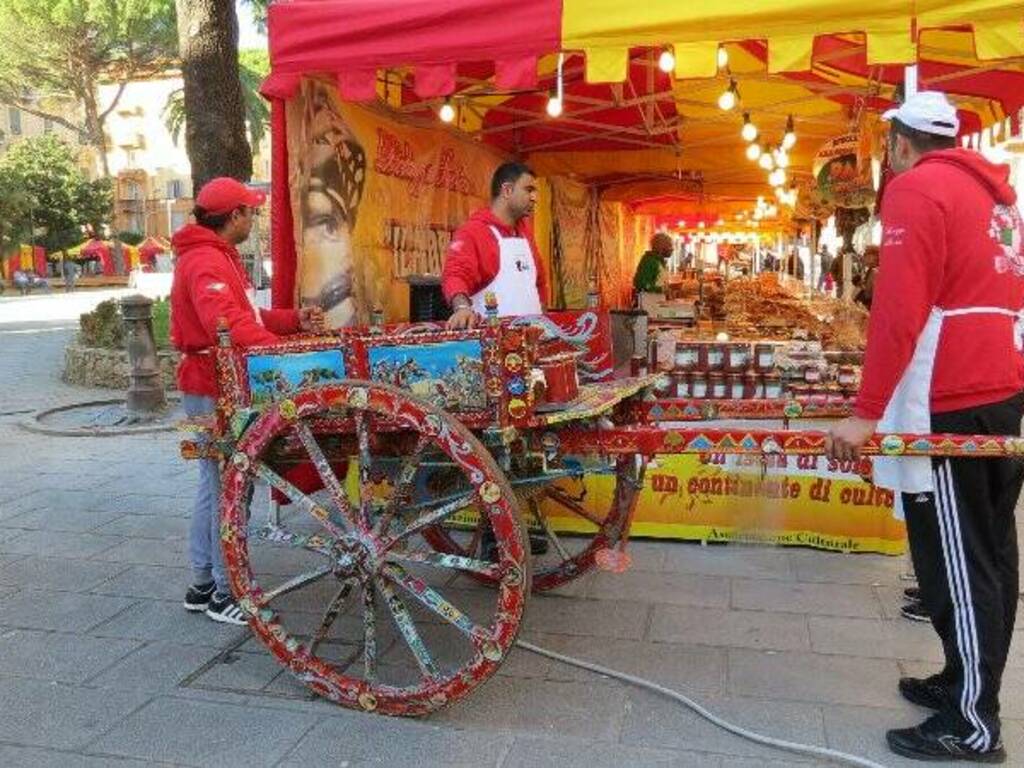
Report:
369,339,487,412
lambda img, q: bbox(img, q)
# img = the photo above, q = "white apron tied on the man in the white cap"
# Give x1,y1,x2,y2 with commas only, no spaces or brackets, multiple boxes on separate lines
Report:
873,306,1024,520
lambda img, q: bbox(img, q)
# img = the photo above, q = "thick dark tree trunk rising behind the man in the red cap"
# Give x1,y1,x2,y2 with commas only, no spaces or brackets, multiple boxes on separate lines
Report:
176,0,253,194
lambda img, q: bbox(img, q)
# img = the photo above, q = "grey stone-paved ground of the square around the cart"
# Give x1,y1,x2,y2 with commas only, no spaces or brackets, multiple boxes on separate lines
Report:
0,296,1024,768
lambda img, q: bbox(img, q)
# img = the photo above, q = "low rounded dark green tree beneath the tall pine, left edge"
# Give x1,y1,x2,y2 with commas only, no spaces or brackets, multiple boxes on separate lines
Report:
0,133,113,251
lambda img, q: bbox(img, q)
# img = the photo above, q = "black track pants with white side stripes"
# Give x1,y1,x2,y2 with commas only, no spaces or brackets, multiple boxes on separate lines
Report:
903,394,1024,751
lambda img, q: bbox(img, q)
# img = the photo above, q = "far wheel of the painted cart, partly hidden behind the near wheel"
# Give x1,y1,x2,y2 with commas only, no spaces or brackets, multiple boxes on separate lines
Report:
424,455,646,592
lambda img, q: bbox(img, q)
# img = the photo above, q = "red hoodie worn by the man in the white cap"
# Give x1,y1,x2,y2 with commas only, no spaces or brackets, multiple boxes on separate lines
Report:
854,148,1024,419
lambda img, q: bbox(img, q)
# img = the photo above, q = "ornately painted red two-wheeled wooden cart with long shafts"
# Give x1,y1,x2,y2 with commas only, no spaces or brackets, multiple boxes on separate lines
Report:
183,299,1024,716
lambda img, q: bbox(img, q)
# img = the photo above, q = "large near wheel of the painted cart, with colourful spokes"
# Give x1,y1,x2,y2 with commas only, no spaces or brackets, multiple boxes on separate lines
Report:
221,382,530,716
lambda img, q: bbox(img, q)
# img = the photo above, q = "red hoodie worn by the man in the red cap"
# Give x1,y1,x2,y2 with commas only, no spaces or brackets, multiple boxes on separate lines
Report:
171,224,299,396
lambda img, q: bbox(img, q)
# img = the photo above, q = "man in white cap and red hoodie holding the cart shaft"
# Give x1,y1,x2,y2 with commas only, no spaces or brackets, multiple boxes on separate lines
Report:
830,92,1024,763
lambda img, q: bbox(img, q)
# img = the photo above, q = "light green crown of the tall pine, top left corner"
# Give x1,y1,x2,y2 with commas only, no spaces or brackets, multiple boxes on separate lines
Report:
0,0,177,176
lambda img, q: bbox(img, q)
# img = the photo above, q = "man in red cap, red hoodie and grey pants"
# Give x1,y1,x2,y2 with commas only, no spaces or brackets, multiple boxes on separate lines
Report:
171,177,319,625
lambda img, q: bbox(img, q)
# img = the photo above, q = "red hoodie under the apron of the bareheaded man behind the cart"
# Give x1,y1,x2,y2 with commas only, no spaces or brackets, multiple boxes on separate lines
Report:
441,208,548,308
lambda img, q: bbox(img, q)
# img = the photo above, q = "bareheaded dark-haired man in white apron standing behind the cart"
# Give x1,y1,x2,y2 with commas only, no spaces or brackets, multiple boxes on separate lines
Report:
441,163,548,329
